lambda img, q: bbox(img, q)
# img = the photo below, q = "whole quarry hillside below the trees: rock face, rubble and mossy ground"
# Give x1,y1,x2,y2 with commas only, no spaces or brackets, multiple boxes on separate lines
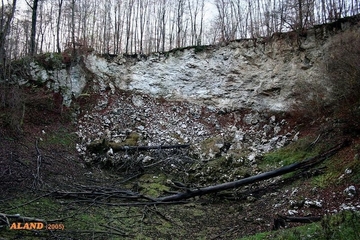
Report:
0,15,360,239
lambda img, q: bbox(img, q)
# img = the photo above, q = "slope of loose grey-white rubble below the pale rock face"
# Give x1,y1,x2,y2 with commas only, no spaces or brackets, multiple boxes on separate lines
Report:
77,88,299,171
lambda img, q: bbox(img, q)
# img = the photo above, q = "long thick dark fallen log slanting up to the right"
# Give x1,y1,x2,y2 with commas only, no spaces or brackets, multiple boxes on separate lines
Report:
154,141,349,202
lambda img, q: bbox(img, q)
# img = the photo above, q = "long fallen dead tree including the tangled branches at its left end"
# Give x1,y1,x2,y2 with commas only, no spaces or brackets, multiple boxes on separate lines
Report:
51,141,349,206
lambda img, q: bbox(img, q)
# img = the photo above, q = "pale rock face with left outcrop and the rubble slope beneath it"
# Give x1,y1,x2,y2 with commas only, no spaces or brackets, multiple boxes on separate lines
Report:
15,21,360,164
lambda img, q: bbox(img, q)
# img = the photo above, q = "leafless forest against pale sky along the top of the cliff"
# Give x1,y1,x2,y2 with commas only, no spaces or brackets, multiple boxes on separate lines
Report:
0,0,360,62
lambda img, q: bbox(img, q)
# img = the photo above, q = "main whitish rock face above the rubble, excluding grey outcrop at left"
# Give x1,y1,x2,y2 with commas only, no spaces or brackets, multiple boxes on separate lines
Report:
85,34,329,111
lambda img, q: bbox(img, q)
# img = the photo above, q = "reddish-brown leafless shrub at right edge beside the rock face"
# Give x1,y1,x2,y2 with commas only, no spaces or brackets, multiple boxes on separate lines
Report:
325,31,360,134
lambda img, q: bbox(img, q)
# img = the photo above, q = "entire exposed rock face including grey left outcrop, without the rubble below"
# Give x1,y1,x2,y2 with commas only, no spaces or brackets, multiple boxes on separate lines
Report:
19,21,359,111
